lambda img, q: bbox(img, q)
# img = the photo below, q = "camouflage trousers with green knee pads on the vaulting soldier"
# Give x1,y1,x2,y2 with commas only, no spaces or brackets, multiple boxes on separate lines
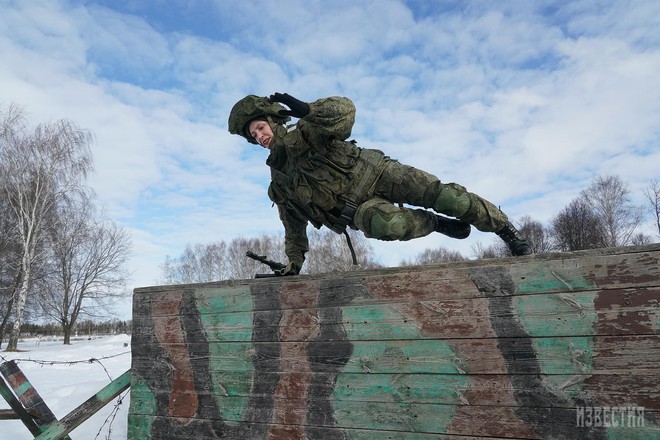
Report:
353,160,508,241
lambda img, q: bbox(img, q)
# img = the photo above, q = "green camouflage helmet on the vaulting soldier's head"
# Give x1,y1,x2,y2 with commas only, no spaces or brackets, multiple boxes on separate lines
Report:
227,95,290,144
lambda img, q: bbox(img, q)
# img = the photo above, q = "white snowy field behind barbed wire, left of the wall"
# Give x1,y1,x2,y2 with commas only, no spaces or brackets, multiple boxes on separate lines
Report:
0,335,131,440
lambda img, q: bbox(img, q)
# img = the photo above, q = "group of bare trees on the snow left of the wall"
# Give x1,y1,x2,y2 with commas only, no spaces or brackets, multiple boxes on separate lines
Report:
0,104,131,350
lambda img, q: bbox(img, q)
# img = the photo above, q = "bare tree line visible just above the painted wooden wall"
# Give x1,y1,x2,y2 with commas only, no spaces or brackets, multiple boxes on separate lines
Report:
160,175,660,284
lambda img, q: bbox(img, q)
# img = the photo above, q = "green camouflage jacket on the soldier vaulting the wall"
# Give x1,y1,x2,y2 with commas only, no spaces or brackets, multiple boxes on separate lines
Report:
266,97,385,266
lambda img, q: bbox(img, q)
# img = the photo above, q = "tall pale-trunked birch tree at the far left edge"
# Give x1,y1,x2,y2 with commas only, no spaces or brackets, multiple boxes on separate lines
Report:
0,105,92,351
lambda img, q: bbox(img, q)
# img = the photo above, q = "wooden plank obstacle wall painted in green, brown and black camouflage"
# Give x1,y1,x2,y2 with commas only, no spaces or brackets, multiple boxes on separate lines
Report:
128,245,660,440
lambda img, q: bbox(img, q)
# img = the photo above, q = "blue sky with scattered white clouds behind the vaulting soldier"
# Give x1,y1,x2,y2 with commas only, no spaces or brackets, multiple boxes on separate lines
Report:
0,0,660,316
